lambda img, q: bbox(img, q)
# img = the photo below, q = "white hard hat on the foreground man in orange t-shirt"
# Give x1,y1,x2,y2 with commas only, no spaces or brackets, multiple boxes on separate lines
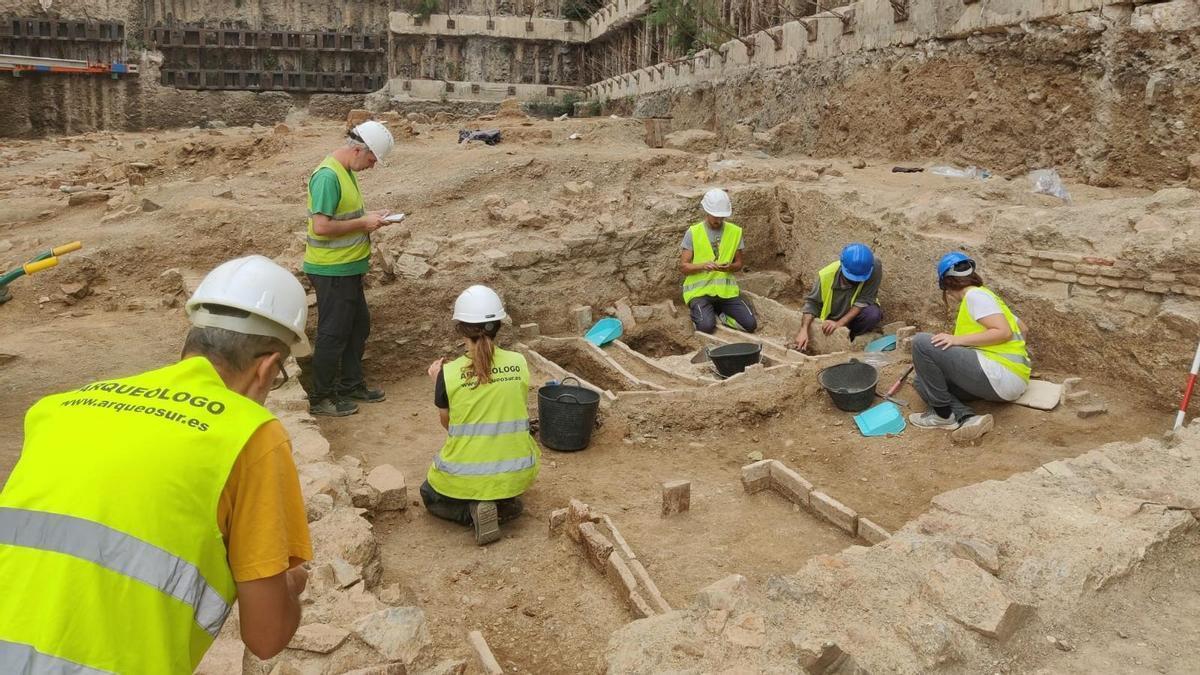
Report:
187,256,312,357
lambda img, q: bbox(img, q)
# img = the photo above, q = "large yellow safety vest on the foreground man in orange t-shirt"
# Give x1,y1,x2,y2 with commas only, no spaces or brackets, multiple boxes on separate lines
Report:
0,358,274,675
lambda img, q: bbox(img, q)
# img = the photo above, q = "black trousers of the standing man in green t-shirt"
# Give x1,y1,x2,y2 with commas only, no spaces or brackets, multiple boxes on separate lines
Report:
308,274,371,401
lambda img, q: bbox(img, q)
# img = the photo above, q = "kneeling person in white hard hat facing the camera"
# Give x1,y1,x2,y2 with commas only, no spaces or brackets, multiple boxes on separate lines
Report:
679,190,758,333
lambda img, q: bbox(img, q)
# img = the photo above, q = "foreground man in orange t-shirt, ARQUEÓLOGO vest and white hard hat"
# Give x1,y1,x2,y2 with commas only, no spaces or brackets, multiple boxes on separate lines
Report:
0,256,312,674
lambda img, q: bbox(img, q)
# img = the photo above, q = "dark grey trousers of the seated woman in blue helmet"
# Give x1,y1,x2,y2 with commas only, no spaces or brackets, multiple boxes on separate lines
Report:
912,333,1006,422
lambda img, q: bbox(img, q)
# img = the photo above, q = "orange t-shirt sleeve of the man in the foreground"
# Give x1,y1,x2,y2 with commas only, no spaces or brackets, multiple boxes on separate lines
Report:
217,419,312,583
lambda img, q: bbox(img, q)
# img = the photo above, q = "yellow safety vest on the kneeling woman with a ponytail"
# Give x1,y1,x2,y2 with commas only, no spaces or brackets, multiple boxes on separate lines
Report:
426,347,541,501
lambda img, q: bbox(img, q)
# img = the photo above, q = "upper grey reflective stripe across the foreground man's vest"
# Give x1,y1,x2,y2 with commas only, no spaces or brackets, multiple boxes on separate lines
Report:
0,507,230,638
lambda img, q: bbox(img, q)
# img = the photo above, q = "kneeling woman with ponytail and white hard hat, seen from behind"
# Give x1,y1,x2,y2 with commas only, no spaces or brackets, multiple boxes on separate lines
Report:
421,286,541,545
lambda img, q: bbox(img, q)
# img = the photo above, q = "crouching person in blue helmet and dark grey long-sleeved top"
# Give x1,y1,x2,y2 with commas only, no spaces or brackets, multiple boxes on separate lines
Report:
793,244,883,352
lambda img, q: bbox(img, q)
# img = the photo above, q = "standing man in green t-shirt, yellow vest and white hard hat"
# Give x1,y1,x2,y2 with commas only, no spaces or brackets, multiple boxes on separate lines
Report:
304,120,395,417
